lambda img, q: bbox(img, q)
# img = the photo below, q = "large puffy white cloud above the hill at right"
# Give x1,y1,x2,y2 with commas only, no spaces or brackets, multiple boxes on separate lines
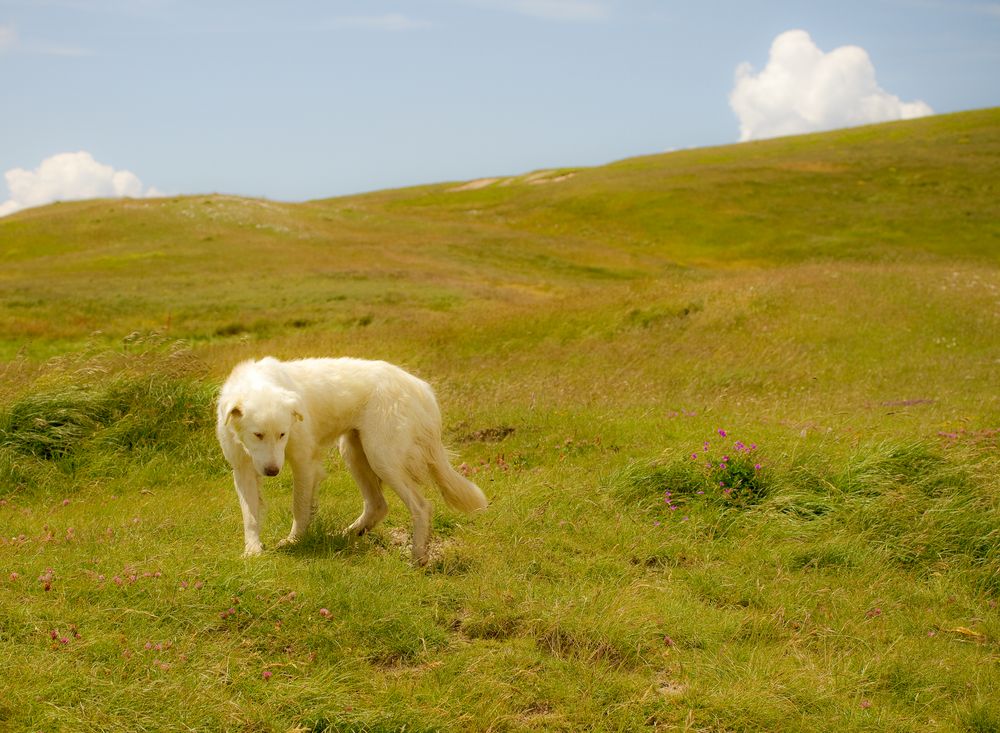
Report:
729,30,934,141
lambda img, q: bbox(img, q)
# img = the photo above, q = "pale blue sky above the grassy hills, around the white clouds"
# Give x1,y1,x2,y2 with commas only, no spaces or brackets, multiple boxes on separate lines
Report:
0,0,1000,210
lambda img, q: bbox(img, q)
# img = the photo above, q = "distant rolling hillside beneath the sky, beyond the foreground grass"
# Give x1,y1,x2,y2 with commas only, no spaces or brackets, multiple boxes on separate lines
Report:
0,109,1000,356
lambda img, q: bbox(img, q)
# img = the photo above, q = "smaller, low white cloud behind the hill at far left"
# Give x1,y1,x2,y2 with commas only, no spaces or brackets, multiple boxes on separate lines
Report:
0,152,162,216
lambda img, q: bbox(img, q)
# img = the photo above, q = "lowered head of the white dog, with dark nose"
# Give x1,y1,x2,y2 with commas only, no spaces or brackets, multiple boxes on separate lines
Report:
222,388,303,476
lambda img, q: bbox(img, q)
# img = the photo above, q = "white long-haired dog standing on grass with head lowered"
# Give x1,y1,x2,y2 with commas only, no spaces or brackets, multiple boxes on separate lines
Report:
216,357,487,565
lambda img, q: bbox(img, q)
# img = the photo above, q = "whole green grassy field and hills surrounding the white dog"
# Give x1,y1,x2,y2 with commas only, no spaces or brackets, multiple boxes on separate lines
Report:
0,110,1000,732
